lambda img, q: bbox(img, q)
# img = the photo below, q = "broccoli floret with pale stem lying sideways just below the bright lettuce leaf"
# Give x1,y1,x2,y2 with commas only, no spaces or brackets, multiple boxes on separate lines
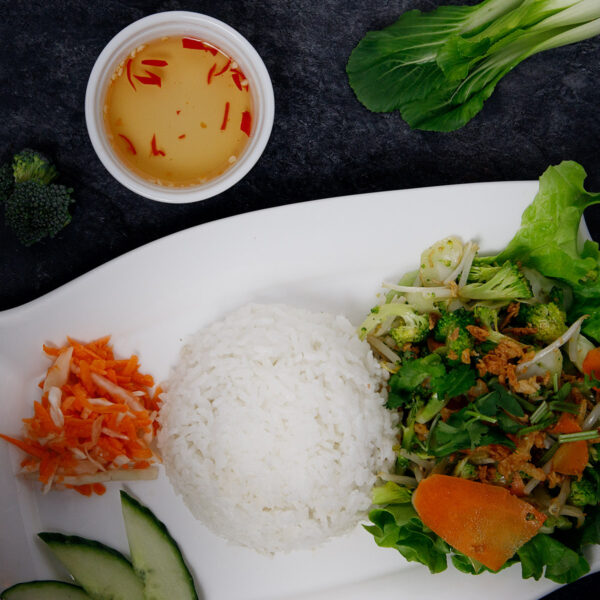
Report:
460,261,532,302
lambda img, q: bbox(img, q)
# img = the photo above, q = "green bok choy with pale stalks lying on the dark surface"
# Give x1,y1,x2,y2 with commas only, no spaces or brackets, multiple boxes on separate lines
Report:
346,0,600,131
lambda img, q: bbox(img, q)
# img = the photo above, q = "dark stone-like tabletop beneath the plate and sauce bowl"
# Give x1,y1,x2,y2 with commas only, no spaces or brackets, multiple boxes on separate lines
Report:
0,0,600,597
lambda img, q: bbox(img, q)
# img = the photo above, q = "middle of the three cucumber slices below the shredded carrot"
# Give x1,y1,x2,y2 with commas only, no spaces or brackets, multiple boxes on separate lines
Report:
38,533,144,600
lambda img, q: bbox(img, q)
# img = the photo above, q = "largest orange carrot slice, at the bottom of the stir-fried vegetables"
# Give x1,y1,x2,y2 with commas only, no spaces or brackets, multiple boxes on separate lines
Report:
412,475,546,571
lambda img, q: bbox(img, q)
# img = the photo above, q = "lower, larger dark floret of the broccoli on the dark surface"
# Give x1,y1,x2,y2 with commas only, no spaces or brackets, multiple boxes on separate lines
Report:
4,181,73,246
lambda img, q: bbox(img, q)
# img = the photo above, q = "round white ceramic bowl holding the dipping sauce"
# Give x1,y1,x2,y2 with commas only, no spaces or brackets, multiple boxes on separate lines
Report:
85,11,275,204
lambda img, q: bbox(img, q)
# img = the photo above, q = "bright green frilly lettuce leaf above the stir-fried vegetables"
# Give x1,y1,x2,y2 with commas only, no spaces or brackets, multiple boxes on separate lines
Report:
483,161,600,343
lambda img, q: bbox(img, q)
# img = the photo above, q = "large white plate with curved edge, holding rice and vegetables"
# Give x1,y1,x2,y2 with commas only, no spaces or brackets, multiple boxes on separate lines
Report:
0,182,598,600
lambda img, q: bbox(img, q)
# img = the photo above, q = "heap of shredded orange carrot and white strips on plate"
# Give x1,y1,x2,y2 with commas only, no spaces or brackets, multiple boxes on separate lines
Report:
0,336,162,496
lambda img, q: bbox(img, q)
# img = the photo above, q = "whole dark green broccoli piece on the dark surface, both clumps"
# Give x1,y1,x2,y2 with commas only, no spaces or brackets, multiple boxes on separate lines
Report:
0,150,74,246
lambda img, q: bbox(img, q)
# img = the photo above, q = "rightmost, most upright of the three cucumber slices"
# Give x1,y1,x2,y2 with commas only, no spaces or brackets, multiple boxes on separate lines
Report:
121,491,198,600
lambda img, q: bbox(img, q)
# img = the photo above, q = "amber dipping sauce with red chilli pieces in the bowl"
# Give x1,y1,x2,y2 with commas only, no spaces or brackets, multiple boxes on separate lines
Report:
104,37,252,187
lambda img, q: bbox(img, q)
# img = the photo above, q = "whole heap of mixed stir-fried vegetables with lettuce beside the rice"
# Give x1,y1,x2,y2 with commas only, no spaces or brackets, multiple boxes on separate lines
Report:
360,163,600,583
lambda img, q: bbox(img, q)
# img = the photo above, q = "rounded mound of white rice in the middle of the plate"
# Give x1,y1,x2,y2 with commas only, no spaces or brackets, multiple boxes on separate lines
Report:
158,305,394,553
